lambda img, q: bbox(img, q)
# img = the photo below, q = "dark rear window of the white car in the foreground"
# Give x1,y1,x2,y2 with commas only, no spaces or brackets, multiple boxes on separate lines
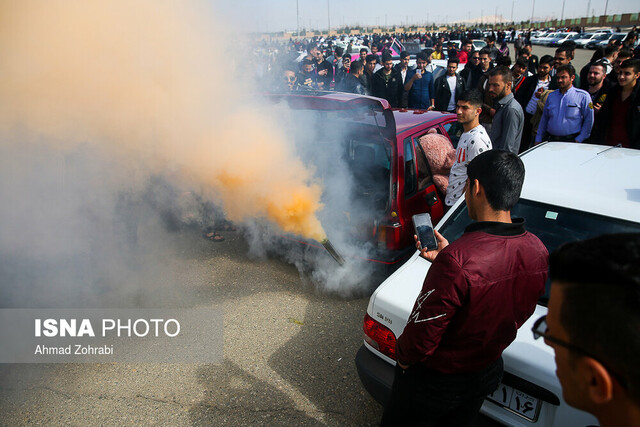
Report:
438,199,640,306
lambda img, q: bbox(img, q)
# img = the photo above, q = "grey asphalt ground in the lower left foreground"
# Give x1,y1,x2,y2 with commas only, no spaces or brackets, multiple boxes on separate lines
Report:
0,230,382,426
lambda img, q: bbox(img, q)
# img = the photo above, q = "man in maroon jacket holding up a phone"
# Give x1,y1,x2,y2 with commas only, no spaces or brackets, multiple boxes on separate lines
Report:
382,150,548,426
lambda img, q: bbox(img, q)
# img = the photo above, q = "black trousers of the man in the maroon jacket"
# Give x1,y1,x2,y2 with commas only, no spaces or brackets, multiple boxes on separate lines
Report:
381,358,503,427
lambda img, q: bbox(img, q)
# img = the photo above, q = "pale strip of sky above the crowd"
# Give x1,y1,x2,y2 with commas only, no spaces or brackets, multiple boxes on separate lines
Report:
210,0,640,32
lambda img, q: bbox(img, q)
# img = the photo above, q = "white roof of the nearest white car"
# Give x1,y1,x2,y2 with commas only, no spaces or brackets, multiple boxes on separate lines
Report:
521,142,640,222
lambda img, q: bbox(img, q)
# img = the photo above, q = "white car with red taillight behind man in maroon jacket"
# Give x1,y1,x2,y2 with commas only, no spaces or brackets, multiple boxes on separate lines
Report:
356,142,640,427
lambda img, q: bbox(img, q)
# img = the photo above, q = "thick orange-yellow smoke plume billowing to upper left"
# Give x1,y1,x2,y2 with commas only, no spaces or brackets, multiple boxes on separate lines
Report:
0,0,324,239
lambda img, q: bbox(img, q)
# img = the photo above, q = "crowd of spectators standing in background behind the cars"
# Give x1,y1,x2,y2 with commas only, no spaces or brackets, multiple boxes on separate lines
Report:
263,28,640,150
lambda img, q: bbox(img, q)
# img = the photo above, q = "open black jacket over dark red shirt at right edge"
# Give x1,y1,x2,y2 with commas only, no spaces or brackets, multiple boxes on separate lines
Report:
590,82,640,148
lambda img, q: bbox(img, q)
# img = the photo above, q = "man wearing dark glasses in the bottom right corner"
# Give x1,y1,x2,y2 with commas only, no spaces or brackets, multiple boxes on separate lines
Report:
533,234,640,427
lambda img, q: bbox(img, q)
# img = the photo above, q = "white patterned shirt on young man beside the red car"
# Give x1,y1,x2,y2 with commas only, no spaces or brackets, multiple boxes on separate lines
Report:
444,125,492,206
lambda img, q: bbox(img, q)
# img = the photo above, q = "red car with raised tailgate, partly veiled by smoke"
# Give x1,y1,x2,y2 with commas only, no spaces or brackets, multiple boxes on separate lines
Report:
269,91,462,268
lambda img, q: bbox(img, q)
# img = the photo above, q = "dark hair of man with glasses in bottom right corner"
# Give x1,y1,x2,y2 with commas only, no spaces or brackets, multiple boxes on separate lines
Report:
549,233,640,404
